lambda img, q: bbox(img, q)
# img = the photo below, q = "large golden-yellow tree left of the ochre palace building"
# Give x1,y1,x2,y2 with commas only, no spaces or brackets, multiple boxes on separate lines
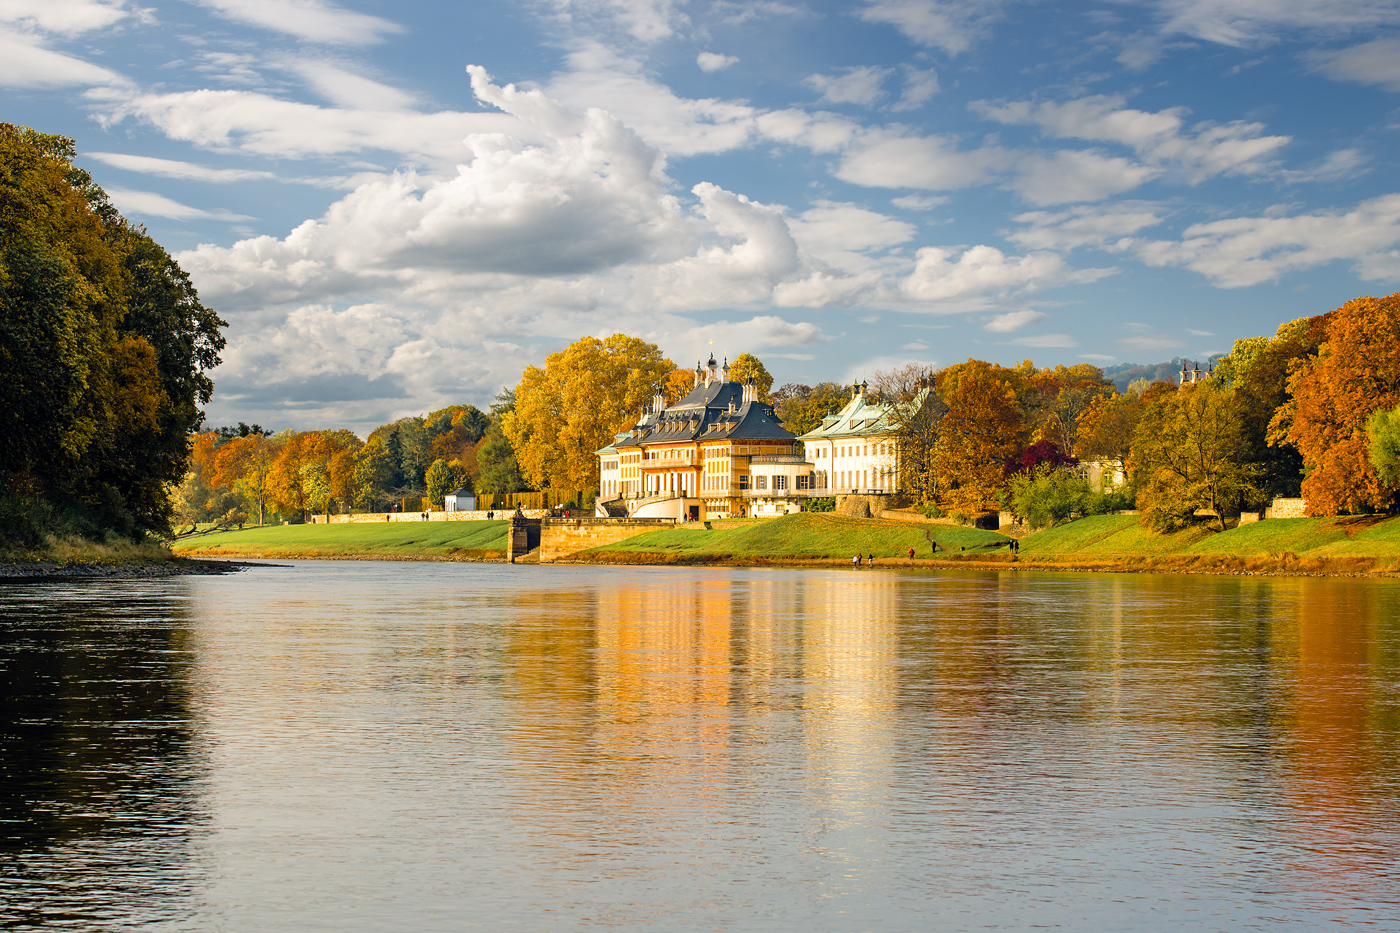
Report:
501,333,676,489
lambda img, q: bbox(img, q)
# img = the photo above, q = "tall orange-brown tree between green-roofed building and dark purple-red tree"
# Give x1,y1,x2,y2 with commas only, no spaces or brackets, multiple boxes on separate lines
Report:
932,360,1023,517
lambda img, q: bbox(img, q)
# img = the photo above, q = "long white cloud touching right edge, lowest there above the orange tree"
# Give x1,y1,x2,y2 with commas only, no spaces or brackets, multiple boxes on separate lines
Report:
1134,195,1400,282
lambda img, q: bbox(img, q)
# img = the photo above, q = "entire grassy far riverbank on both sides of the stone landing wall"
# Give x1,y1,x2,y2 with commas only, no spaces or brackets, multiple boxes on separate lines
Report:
174,513,1400,576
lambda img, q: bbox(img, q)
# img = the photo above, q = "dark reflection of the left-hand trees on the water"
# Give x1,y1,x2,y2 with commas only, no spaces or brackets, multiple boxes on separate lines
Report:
0,581,203,927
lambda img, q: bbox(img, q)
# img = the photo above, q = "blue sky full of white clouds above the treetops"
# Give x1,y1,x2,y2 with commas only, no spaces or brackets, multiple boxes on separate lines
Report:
0,0,1400,430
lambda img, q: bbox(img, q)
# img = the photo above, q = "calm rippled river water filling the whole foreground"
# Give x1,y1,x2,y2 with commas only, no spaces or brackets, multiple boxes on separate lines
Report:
0,562,1400,933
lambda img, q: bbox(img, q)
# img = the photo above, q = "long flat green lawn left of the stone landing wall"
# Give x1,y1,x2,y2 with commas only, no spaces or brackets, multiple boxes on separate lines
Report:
174,521,507,559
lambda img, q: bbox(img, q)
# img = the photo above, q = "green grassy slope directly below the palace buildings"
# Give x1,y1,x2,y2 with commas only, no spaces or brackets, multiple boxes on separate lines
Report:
591,513,1007,559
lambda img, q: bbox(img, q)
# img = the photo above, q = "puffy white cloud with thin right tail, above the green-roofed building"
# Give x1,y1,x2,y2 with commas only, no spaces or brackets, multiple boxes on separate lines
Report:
900,247,1112,301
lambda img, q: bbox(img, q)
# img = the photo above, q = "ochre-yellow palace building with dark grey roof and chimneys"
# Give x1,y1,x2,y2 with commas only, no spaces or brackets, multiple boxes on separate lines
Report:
598,356,815,521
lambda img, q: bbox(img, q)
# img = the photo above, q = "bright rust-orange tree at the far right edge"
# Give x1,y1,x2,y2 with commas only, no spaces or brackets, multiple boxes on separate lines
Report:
1271,293,1400,516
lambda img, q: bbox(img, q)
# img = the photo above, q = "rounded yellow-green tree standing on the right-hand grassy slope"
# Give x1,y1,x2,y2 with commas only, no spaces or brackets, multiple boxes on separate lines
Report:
1133,382,1264,531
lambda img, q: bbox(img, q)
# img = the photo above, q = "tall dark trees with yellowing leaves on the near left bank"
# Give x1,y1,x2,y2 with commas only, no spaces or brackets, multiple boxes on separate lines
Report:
0,123,225,548
